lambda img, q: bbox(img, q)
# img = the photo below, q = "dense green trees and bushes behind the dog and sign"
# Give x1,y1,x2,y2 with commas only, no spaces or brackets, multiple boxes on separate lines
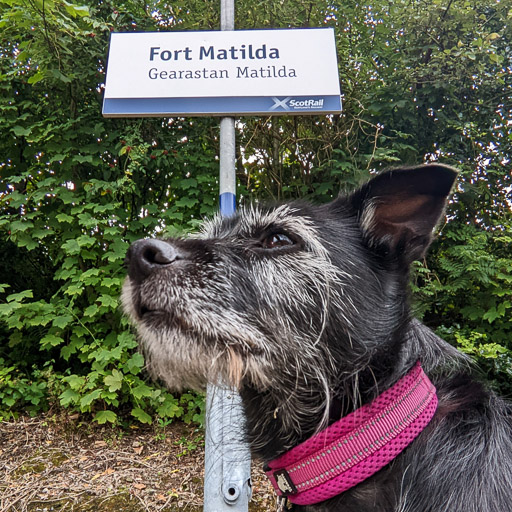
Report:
0,0,512,424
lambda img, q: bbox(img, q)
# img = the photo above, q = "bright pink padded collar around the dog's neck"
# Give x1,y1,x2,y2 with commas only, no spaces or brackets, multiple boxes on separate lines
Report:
266,362,437,505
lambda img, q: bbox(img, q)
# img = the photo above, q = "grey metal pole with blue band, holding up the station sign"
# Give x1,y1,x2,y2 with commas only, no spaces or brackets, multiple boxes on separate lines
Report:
203,0,251,512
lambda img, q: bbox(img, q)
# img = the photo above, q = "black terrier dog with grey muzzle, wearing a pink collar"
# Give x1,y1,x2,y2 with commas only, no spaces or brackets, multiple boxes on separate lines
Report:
123,164,512,512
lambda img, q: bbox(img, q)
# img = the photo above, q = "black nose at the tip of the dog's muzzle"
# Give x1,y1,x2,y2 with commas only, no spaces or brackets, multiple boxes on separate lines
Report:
126,240,183,281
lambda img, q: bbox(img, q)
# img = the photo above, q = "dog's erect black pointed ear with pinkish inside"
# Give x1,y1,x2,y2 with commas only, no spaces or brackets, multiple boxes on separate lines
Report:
351,164,457,263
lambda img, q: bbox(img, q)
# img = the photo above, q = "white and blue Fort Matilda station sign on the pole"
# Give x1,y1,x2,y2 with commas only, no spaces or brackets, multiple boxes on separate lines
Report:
103,28,341,117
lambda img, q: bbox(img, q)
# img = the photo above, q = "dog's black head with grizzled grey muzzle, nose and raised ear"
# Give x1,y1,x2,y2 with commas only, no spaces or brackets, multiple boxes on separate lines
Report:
123,164,456,407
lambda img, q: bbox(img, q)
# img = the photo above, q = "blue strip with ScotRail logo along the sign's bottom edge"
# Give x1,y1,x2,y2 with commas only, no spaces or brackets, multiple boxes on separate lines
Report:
103,96,341,117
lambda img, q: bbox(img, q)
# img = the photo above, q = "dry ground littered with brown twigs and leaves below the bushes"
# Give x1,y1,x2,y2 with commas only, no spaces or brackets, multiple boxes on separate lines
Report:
0,416,275,512
